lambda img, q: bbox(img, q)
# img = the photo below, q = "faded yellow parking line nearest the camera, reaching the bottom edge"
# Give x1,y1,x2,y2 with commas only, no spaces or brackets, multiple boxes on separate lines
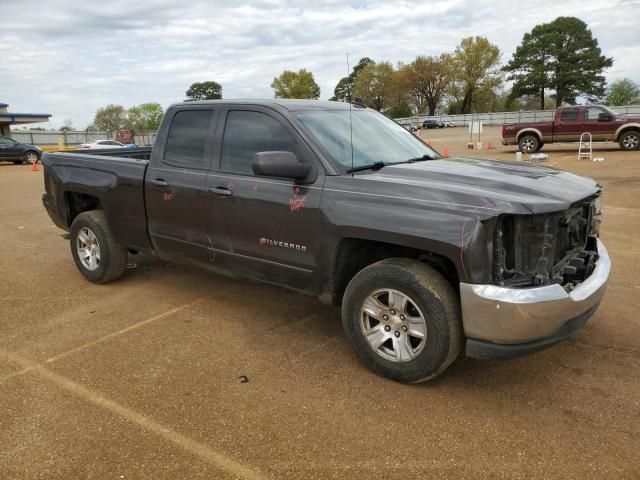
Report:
0,348,267,480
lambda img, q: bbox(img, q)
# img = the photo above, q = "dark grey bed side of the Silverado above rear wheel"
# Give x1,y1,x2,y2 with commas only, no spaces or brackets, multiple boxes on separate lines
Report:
42,148,151,250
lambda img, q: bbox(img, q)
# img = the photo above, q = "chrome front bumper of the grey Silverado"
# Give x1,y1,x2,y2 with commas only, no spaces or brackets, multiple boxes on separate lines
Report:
460,240,611,351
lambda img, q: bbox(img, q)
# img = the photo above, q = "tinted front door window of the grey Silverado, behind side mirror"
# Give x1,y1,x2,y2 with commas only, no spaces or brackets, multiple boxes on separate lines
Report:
221,110,296,175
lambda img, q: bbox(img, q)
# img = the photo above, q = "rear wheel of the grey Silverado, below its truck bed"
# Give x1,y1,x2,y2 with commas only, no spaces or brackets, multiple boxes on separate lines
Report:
70,210,128,283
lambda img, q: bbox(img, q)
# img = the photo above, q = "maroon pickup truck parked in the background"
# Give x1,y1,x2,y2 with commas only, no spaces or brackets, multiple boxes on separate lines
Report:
502,105,640,153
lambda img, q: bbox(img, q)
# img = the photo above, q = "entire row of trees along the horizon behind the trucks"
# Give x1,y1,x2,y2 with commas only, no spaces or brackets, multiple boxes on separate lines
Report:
84,17,640,133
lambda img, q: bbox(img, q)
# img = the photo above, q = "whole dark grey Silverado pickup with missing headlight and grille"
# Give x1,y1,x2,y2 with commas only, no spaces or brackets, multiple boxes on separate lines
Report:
43,100,611,382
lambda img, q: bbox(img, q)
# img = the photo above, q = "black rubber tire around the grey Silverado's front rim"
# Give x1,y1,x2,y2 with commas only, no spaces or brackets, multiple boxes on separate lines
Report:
342,258,463,383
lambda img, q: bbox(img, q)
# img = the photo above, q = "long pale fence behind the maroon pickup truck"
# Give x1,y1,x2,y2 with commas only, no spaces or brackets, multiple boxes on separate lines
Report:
395,105,640,125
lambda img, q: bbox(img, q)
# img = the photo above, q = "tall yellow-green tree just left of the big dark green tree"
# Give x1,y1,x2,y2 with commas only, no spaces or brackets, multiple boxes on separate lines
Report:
451,37,502,113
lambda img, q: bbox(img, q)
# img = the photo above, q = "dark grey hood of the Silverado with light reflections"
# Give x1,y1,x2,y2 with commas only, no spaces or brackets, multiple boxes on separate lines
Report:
361,157,600,213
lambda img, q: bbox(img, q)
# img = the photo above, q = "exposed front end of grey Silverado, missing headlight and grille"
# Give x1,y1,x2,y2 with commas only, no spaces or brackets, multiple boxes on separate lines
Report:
492,192,602,292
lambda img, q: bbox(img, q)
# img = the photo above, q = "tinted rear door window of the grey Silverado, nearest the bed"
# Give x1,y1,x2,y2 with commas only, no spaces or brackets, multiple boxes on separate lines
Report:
163,110,213,170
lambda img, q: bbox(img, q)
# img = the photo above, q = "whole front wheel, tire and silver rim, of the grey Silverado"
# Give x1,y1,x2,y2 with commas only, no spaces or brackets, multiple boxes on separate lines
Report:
342,258,462,383
